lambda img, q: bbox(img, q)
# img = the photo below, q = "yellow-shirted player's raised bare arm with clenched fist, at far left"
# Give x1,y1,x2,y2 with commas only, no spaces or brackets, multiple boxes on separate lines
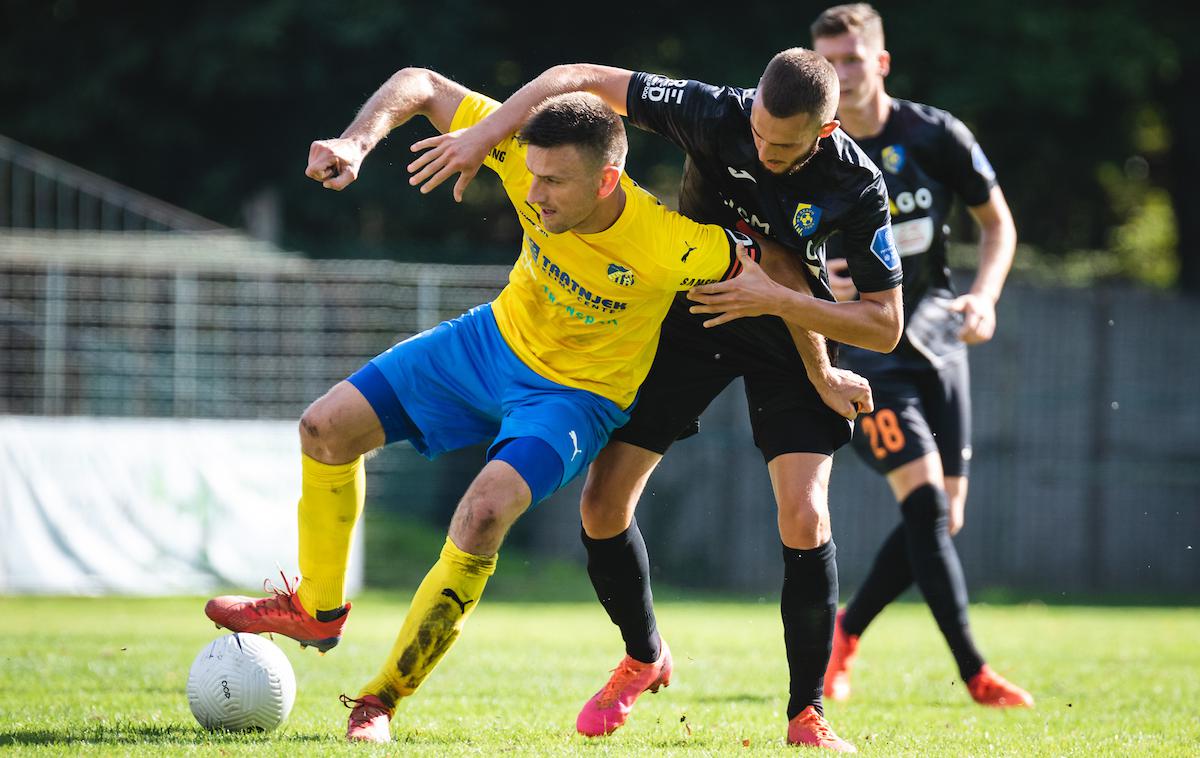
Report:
305,68,467,190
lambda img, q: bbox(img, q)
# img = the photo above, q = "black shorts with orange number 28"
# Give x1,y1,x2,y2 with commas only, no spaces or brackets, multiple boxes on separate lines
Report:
841,344,971,476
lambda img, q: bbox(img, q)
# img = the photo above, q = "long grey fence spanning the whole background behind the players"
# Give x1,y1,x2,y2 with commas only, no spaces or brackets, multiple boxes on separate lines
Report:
0,233,1200,595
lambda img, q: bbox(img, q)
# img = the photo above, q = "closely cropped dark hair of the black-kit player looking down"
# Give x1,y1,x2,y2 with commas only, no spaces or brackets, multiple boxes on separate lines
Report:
758,48,838,124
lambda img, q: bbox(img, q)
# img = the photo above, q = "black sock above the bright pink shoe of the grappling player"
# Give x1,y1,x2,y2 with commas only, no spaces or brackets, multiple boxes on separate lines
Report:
581,519,662,663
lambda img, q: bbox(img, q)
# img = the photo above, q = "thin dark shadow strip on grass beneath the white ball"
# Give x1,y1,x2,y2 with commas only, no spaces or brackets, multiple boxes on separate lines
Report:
0,723,331,747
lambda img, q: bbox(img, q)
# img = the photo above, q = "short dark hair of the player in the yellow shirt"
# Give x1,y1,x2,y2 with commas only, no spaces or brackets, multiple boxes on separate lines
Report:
517,92,629,166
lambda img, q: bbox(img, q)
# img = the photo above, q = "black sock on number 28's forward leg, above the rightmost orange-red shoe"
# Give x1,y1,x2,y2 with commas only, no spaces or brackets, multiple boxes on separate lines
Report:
900,485,983,681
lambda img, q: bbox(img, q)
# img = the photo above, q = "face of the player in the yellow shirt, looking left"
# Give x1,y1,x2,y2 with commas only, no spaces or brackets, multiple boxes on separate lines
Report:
526,145,604,234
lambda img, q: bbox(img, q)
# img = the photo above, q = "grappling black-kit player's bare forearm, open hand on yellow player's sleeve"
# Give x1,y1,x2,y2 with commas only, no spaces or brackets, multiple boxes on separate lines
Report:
688,251,904,353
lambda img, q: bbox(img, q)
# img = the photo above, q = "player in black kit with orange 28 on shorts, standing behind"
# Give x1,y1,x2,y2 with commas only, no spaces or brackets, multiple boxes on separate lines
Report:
812,4,1033,706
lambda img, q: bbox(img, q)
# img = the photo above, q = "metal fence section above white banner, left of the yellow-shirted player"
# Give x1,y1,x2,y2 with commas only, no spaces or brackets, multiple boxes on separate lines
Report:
0,233,506,419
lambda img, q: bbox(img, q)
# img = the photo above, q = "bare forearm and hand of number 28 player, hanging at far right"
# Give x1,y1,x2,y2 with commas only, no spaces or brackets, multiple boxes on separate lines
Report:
950,187,1016,344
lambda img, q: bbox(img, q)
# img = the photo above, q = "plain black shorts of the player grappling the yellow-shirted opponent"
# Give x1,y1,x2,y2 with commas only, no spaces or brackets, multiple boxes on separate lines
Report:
612,301,852,462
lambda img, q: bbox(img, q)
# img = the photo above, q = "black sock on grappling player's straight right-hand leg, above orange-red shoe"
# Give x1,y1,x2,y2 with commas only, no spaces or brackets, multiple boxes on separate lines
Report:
779,540,838,721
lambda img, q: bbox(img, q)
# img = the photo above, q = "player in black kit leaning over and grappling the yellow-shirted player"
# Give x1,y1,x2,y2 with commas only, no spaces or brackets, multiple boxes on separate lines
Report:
409,48,901,751
